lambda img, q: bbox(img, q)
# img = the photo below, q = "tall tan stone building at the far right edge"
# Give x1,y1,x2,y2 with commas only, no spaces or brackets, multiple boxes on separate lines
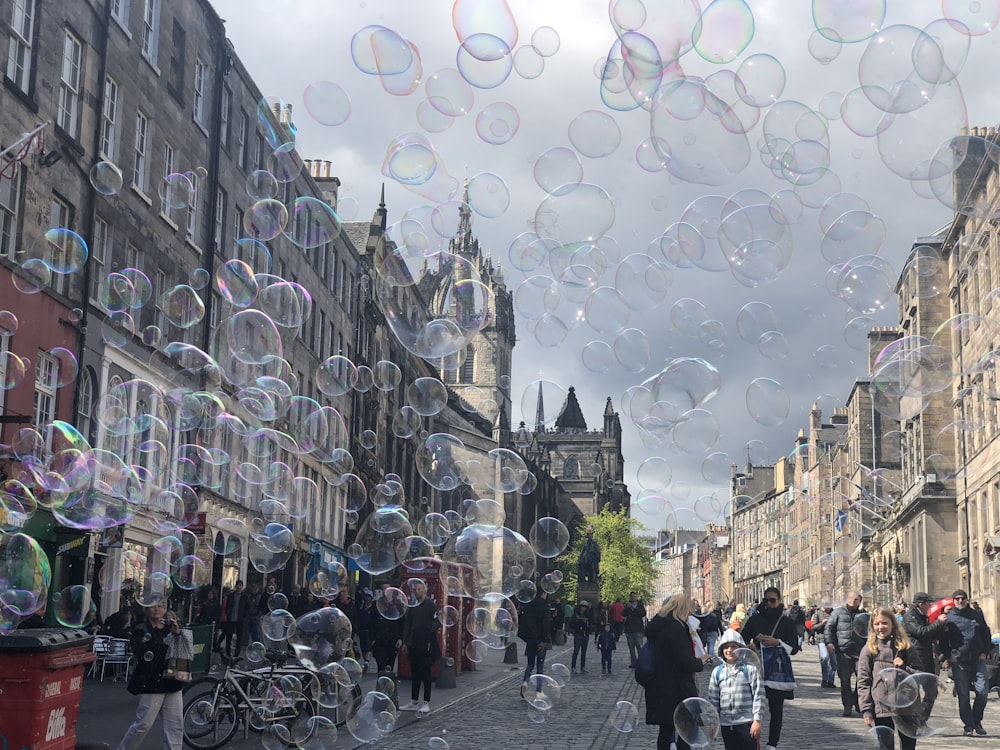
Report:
936,128,1000,629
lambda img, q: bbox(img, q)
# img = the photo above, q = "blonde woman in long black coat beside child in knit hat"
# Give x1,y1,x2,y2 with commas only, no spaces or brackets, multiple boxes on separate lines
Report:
646,594,709,750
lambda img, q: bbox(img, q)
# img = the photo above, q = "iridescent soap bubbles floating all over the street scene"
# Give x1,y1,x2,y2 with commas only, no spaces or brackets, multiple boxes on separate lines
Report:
0,0,1000,748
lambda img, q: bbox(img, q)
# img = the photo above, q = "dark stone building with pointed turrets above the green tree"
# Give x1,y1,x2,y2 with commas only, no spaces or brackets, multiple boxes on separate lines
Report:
526,386,631,516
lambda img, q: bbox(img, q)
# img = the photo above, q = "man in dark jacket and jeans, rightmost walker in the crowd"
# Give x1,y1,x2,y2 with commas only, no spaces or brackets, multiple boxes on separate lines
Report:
947,589,993,737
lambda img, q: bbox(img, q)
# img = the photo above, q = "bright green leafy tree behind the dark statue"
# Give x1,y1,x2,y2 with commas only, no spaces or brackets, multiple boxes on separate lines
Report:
557,508,656,602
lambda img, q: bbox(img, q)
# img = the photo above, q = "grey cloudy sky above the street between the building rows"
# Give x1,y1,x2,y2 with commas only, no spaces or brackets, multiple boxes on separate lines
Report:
213,0,1000,526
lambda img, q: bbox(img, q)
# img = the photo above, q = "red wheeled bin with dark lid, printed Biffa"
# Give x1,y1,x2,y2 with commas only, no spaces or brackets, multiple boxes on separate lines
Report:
0,628,95,750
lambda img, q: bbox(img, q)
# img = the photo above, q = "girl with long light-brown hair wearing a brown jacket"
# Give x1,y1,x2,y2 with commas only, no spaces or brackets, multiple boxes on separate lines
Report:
858,608,917,750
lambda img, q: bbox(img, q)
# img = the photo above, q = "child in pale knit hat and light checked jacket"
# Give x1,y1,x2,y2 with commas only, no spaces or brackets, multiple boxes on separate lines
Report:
708,628,764,750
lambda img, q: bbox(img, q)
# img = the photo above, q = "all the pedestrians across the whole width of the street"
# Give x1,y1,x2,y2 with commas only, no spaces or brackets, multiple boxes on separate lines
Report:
104,578,996,750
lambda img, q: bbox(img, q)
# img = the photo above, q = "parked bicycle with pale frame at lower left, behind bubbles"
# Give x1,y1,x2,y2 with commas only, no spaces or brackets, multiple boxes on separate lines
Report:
183,650,361,750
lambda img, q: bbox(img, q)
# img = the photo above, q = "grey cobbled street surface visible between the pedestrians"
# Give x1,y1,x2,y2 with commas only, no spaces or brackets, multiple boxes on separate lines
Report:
77,641,1000,750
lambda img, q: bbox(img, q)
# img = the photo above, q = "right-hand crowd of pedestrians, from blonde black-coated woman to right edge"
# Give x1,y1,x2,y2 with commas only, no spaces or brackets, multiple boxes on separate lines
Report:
633,587,1000,750
